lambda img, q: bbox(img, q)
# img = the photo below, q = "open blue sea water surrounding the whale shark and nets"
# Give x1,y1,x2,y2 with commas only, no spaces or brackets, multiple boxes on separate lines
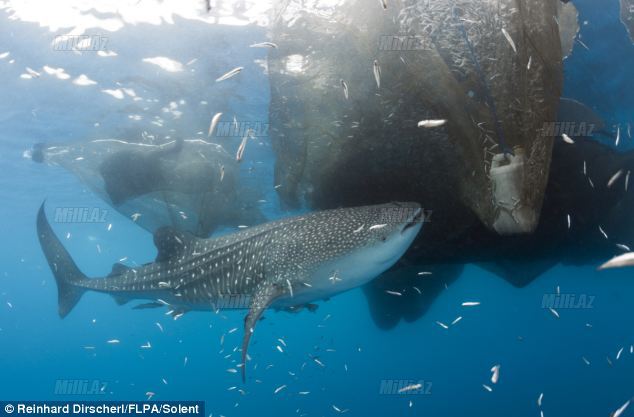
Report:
0,0,634,417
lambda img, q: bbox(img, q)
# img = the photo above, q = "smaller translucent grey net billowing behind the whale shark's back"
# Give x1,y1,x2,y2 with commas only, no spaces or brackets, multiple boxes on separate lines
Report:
28,139,265,237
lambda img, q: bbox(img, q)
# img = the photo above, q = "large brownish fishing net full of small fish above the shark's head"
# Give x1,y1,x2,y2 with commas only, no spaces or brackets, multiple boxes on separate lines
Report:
269,0,563,234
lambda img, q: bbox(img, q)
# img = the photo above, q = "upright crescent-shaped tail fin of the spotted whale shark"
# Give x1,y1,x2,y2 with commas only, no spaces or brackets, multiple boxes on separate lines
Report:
37,203,86,318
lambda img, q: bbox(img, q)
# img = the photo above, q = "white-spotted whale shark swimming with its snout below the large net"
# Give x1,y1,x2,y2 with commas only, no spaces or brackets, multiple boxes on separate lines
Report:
37,203,424,379
